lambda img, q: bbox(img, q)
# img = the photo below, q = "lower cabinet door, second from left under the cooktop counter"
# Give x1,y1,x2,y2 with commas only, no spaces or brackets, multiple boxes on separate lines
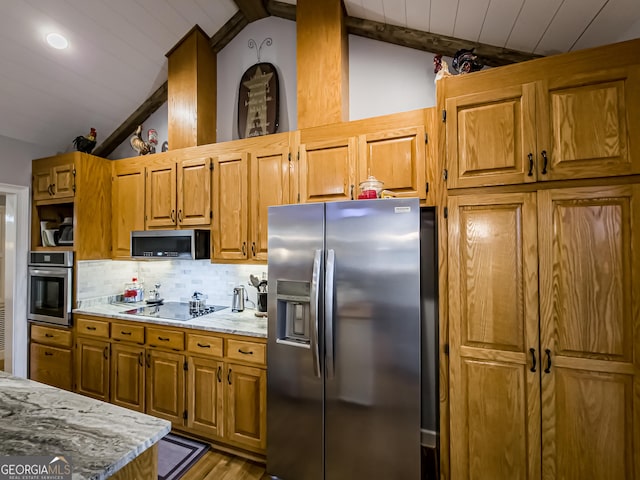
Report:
111,343,145,413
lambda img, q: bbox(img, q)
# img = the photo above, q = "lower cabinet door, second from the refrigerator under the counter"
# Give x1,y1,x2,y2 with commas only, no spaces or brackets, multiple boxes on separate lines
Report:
187,357,224,437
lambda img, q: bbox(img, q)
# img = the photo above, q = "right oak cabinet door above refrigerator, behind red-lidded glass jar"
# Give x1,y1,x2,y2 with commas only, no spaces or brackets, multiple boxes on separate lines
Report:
358,126,427,199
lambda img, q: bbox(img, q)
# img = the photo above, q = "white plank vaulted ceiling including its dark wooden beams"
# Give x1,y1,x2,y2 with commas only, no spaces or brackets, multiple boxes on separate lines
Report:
0,0,640,155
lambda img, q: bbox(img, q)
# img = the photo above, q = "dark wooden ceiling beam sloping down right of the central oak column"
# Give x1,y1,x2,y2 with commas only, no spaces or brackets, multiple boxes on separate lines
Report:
345,17,540,67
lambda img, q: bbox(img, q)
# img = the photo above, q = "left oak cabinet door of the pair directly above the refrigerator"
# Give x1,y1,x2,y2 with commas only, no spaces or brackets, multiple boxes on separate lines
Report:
299,137,358,203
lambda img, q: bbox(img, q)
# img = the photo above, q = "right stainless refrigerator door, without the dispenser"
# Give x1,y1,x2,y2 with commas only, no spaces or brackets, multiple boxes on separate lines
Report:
324,199,420,480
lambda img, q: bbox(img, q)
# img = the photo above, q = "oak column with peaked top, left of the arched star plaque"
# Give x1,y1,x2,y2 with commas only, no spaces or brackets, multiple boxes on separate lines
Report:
166,25,217,150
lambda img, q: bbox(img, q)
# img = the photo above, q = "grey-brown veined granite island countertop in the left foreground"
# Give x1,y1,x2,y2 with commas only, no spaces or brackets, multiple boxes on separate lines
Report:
0,372,171,480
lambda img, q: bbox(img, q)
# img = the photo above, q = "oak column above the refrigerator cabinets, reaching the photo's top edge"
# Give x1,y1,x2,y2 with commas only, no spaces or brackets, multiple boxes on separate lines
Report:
296,0,349,128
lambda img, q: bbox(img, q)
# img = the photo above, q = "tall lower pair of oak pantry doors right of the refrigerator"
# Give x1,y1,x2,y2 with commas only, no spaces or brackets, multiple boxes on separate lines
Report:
448,185,640,480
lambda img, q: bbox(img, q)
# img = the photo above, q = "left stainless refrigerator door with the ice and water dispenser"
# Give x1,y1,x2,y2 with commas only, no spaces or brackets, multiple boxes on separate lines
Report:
267,203,324,480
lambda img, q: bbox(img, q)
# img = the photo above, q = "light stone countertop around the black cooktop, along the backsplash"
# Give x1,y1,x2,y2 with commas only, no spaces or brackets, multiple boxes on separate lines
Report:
73,300,267,338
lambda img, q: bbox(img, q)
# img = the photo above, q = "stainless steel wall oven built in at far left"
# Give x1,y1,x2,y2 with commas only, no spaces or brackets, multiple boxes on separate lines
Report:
27,251,73,326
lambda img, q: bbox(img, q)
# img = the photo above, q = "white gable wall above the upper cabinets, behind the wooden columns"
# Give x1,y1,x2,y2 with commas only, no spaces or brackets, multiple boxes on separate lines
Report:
109,17,444,159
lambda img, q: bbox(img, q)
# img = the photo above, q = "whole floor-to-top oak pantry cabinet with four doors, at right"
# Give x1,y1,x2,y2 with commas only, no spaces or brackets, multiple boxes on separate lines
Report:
438,37,640,480
